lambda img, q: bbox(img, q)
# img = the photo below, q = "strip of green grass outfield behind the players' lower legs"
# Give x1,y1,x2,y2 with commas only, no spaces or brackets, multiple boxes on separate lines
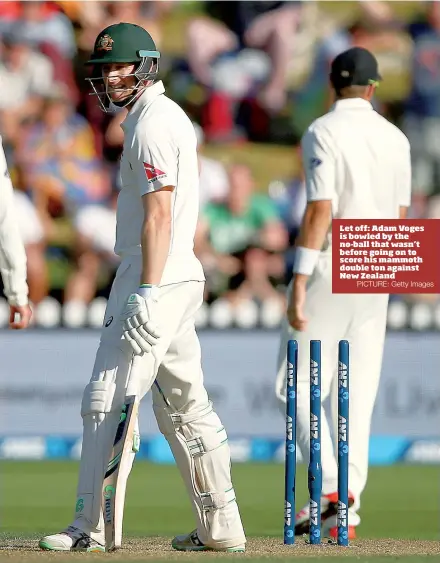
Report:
0,461,440,540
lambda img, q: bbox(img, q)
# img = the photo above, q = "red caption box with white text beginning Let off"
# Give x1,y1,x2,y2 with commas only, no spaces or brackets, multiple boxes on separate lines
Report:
332,219,440,293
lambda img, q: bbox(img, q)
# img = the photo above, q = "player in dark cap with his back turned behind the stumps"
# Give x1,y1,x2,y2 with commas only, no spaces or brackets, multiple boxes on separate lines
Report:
276,48,411,539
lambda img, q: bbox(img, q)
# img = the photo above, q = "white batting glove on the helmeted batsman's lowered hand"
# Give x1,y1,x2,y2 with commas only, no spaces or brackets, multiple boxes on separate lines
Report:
121,286,160,355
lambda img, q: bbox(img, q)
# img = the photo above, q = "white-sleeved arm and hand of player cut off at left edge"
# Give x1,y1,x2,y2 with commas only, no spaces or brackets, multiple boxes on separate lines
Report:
0,137,32,330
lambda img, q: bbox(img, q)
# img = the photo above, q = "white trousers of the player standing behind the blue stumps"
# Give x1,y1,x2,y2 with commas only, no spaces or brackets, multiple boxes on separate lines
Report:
275,254,389,526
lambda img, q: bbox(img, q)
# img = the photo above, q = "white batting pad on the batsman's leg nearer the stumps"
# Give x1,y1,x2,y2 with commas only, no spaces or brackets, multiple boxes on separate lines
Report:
154,403,246,548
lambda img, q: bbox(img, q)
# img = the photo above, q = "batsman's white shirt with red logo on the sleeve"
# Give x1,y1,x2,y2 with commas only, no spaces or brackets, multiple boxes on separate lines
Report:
115,81,205,285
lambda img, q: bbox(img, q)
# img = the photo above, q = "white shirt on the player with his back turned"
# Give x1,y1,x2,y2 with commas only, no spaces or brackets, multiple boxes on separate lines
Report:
301,98,411,250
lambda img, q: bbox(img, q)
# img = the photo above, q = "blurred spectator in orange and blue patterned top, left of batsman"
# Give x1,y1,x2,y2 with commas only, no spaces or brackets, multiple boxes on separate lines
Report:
18,87,111,320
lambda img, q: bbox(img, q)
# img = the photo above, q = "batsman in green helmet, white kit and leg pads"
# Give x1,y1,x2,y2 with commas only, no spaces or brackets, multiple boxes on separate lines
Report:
40,23,246,551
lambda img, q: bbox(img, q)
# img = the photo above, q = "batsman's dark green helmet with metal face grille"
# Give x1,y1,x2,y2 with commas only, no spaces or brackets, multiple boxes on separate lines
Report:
86,22,160,112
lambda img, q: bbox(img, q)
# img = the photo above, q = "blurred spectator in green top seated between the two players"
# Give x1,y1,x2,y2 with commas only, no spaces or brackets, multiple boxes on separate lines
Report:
195,164,287,304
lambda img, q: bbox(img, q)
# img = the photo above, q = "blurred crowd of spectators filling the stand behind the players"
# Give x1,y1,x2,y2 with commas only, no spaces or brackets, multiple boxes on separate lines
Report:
0,0,440,326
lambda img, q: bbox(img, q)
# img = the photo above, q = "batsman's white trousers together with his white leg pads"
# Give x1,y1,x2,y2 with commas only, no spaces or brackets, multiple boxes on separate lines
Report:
73,256,246,548
